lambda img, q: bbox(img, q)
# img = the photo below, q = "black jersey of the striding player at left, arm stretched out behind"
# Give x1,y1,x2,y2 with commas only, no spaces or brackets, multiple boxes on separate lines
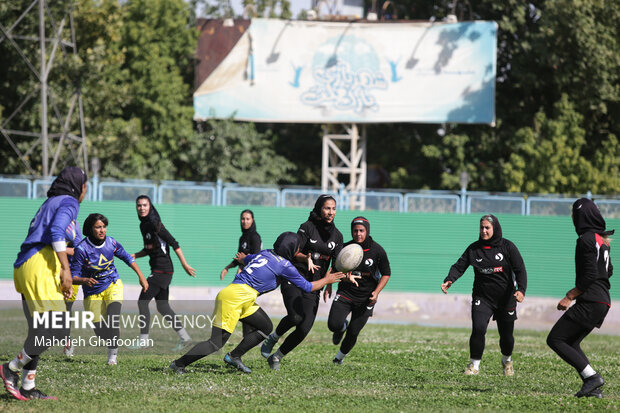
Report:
140,222,179,288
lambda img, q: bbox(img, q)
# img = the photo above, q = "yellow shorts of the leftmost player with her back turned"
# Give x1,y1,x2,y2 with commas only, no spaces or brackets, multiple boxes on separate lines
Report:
13,245,67,314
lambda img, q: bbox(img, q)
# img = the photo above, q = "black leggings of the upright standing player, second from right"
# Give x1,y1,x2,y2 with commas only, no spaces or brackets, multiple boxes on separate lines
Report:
469,302,515,360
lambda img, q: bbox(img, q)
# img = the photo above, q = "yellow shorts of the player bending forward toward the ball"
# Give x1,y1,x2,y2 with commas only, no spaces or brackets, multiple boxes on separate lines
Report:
213,284,260,334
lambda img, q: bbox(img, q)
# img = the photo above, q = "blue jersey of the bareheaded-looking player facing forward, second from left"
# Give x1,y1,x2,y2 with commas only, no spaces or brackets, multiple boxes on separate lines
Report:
71,237,135,297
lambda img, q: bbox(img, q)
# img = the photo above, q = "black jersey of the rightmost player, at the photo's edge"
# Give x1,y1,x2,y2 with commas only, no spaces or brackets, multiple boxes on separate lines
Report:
575,231,613,305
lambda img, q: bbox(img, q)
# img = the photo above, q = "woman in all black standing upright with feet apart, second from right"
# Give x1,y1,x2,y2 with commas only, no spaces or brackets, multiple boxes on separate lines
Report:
441,215,527,376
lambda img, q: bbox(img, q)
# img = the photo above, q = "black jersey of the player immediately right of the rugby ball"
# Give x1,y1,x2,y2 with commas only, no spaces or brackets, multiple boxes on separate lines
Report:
337,240,391,303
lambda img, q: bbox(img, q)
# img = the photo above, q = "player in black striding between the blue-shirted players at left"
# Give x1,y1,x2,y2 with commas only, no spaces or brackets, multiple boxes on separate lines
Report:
132,195,196,351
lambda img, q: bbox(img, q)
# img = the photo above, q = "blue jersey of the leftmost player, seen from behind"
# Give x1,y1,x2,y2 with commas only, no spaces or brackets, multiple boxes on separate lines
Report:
13,195,80,268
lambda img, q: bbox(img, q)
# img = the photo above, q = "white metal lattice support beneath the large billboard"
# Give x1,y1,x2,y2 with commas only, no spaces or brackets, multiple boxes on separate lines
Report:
321,124,367,210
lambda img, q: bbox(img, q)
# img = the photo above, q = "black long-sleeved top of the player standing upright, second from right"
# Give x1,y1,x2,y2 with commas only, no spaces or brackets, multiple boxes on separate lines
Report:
444,238,527,306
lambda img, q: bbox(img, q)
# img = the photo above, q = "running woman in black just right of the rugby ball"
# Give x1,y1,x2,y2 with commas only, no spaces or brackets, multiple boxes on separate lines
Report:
327,217,391,364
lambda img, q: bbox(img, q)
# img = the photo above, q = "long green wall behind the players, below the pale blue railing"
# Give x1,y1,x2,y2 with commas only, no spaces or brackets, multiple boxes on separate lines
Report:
0,197,620,299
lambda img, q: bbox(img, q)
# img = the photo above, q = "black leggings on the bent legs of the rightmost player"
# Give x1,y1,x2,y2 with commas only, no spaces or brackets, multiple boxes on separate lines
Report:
547,314,594,373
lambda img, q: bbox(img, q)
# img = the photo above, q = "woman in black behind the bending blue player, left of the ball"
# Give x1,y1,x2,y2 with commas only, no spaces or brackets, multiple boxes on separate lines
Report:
261,195,343,370
